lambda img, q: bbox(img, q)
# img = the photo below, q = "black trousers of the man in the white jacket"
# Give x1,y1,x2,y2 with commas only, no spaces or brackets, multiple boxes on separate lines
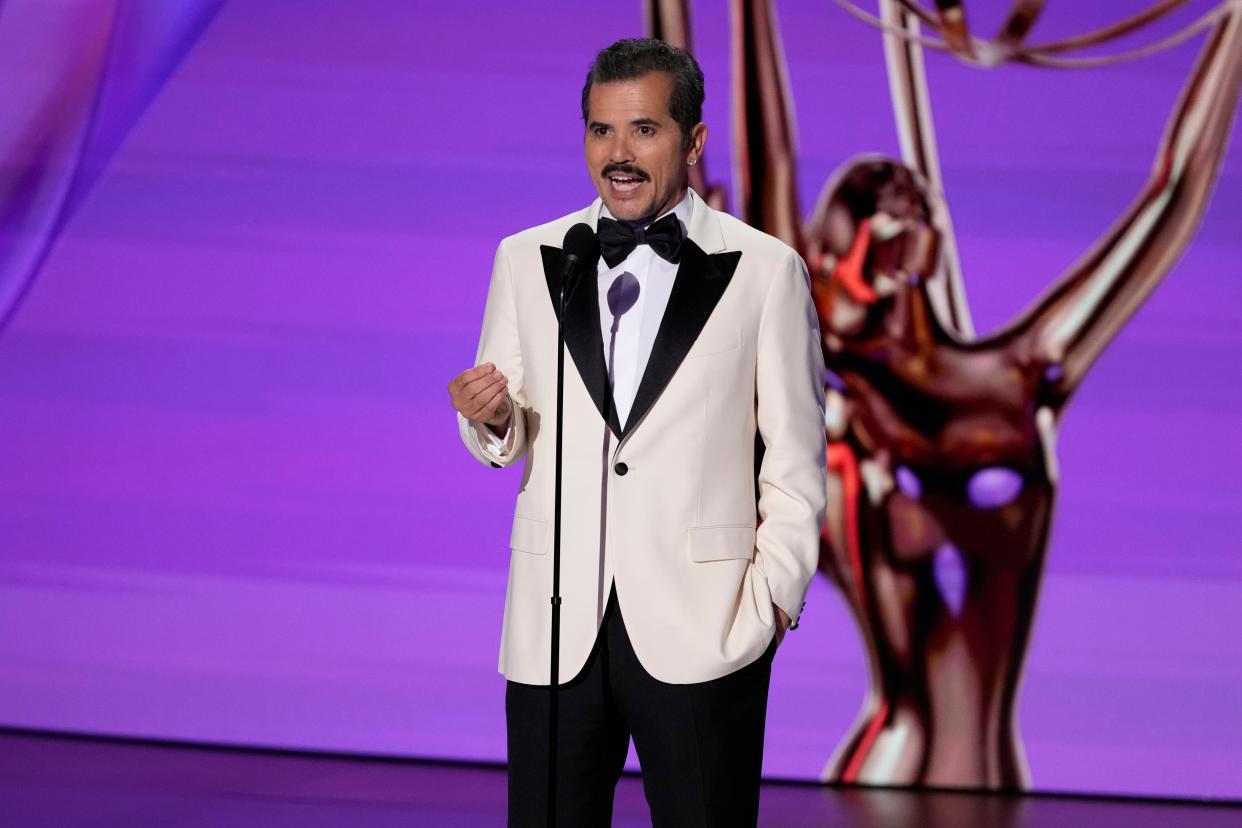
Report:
504,590,776,828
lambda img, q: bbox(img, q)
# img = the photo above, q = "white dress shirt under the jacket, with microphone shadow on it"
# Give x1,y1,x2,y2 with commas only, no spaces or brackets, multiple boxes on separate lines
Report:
474,191,694,457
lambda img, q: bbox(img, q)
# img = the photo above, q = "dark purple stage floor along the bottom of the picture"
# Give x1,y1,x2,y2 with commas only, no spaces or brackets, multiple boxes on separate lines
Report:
0,730,1242,828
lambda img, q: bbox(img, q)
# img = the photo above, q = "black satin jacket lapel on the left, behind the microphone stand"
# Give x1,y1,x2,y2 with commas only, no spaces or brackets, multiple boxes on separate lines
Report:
539,245,621,437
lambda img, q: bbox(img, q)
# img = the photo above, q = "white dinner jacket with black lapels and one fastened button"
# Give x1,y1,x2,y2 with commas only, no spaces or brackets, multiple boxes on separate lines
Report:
458,192,826,684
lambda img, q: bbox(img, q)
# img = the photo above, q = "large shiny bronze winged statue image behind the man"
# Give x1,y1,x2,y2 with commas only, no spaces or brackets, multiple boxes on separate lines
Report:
655,0,1242,788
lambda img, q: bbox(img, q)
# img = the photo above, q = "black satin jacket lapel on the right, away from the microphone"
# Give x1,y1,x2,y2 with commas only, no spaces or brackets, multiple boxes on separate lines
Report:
625,240,741,437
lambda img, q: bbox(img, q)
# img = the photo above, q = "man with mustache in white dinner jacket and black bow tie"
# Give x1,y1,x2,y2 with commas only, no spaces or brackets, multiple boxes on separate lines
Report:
448,40,825,828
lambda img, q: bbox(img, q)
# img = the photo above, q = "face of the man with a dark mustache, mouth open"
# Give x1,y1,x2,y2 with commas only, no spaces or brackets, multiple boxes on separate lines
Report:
586,72,707,221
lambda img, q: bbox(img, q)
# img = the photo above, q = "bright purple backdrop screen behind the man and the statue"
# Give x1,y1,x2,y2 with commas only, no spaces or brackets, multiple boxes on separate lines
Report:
0,0,1242,798
